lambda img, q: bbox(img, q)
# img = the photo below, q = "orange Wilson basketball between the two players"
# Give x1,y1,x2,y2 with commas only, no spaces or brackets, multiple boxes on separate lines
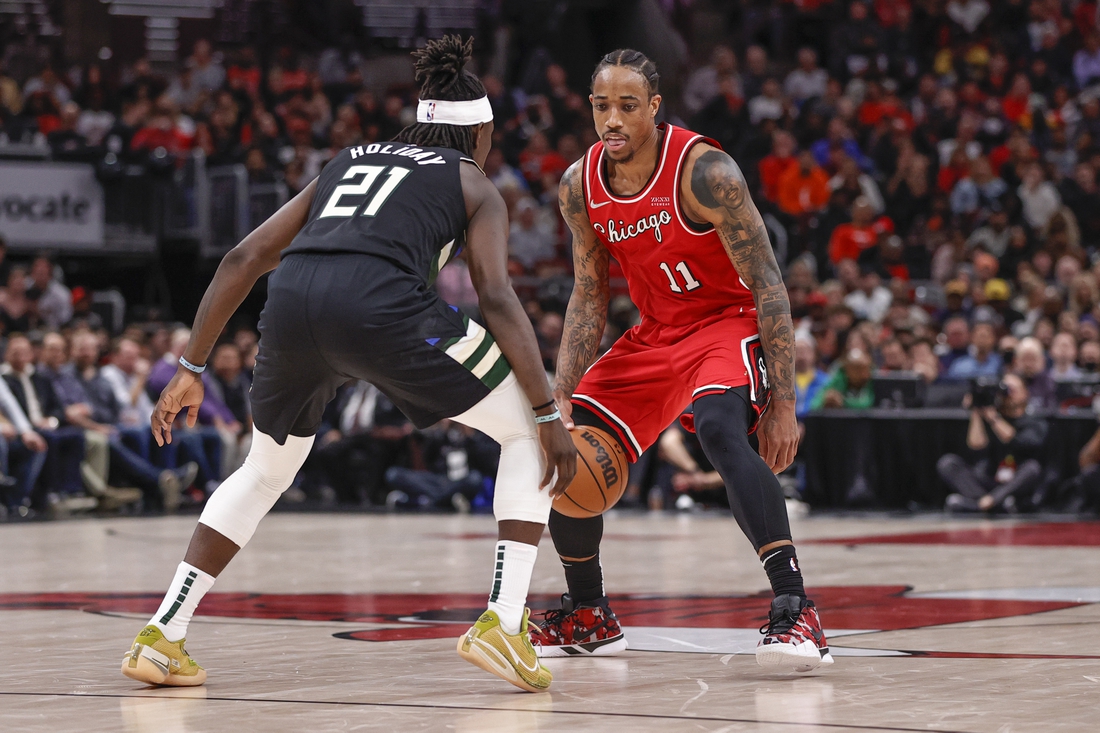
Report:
553,426,629,512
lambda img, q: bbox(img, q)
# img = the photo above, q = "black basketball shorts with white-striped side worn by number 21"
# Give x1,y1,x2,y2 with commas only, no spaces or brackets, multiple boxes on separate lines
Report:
252,253,510,445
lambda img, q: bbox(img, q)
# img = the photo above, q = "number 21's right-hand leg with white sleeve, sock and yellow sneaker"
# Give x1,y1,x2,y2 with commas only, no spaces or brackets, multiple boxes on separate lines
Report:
453,373,553,692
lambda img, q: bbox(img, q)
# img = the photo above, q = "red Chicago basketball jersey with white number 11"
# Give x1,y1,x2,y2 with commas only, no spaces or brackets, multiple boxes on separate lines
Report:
584,124,756,333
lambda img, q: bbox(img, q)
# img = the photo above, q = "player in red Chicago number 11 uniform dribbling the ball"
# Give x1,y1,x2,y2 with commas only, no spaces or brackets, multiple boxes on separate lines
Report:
532,50,833,671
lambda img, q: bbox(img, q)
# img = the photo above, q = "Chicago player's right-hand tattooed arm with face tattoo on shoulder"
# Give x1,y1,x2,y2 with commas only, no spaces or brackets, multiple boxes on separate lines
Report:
680,144,799,473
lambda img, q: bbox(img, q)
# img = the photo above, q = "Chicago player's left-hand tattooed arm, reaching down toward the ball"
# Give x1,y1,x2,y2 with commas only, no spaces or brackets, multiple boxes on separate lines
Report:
553,158,611,427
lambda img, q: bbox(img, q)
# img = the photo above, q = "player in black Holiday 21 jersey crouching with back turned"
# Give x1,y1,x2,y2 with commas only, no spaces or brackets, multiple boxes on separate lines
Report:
122,36,576,692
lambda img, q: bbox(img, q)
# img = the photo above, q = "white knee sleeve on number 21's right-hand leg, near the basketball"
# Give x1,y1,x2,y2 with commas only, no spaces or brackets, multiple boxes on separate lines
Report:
453,374,551,524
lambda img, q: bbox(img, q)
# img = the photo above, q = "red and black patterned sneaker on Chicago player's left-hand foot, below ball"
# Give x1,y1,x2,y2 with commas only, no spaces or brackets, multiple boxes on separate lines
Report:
529,593,627,657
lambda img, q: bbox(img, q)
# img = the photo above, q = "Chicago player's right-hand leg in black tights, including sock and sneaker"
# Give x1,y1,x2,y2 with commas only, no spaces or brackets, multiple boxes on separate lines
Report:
693,385,833,671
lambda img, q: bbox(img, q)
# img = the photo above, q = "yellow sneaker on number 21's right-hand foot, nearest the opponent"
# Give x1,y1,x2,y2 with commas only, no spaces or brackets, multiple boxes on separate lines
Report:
459,609,553,692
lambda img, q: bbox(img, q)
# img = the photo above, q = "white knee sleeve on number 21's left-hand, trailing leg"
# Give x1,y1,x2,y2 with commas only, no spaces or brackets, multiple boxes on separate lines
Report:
199,427,314,547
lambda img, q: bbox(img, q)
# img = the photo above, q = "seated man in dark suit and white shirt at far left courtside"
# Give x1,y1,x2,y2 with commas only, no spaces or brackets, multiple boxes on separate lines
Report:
0,335,85,506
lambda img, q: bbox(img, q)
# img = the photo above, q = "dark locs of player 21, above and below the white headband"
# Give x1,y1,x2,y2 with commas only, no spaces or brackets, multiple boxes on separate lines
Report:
394,35,485,155
